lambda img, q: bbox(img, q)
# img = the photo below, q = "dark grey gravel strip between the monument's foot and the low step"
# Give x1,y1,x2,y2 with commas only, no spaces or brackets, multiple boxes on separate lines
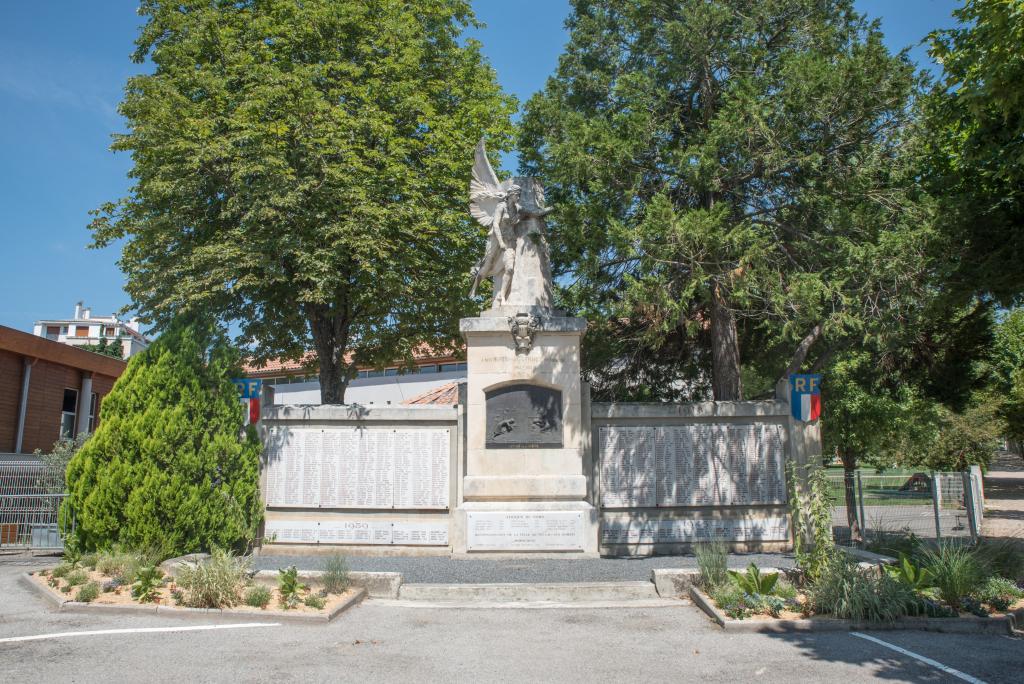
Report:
255,554,796,584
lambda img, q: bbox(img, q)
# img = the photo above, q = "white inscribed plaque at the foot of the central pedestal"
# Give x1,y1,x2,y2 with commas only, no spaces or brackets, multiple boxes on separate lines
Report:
466,511,584,551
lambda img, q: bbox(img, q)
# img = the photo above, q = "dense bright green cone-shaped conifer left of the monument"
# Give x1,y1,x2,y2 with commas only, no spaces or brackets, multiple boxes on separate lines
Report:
61,322,262,555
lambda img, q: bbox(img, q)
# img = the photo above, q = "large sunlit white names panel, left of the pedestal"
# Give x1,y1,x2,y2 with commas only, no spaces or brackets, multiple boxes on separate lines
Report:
264,426,451,509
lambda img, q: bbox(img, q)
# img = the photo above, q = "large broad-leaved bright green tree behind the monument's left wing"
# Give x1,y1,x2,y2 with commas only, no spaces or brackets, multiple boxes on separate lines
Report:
92,0,514,403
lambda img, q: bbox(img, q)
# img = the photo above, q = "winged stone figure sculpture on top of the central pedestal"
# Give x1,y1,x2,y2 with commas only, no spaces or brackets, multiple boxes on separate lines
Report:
469,139,551,308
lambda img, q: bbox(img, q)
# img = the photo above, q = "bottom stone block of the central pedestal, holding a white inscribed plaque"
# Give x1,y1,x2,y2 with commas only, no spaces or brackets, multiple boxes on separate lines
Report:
452,501,598,558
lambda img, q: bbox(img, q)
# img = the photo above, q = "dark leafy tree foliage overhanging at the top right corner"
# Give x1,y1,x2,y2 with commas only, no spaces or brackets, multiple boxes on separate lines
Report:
924,0,1024,305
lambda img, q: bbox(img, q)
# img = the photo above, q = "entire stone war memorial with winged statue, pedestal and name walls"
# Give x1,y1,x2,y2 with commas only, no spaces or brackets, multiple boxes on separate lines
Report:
251,141,820,556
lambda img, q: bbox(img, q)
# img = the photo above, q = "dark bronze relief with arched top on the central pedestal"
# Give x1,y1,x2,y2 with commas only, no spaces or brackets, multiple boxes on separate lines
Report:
485,384,562,448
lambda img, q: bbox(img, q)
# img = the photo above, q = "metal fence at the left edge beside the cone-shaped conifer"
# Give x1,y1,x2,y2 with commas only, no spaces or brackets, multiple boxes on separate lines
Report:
0,461,66,549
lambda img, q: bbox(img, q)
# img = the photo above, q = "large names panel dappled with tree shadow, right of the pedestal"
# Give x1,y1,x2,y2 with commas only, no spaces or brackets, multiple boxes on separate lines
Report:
599,423,786,508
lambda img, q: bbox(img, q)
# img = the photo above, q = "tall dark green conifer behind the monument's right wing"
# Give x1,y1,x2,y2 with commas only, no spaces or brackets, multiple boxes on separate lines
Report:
520,0,930,399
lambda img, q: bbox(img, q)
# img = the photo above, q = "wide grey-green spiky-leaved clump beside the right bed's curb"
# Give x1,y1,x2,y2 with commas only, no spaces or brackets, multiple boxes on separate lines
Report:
810,557,919,623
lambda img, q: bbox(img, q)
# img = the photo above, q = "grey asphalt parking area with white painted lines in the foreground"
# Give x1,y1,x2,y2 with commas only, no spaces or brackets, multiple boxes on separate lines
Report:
0,559,1024,683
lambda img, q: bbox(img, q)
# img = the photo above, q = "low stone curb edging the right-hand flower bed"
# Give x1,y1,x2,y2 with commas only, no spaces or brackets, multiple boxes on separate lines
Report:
690,586,1015,635
